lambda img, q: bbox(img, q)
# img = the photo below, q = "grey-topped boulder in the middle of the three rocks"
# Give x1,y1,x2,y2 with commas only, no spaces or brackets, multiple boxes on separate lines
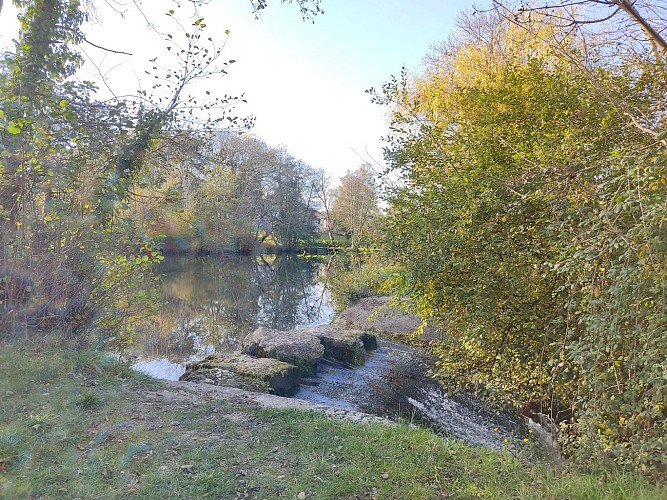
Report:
242,327,325,375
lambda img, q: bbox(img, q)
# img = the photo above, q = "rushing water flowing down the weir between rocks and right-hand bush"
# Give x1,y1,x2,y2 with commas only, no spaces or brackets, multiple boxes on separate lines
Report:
294,340,532,452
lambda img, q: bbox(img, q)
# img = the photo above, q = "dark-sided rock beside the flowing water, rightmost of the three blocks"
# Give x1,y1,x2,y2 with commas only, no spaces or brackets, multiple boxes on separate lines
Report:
294,325,377,366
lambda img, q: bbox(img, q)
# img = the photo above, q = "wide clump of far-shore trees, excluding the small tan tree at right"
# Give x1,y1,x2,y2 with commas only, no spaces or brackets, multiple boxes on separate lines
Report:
131,132,326,254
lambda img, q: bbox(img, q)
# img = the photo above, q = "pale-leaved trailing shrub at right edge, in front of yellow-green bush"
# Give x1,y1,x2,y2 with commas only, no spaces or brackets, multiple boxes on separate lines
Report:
557,153,667,475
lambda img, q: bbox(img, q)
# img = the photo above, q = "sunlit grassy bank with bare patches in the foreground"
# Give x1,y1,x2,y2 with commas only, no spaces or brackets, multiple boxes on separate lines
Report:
0,345,667,500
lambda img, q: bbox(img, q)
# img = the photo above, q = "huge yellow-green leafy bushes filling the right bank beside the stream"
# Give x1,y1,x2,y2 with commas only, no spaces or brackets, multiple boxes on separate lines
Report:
376,8,667,475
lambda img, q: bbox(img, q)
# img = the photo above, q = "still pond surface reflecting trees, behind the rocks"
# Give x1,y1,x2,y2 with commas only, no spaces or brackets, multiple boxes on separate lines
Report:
128,256,333,380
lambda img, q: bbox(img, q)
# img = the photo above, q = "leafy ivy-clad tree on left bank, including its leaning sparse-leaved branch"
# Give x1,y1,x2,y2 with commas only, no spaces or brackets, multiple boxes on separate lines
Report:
0,0,318,338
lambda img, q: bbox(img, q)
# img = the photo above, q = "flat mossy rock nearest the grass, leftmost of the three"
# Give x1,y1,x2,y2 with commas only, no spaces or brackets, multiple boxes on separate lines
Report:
179,354,301,396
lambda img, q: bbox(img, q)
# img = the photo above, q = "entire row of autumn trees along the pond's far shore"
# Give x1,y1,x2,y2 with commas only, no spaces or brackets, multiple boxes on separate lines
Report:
128,132,377,254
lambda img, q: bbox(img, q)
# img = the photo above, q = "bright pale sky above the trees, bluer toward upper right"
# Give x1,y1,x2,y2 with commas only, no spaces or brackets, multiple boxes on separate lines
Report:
0,0,472,178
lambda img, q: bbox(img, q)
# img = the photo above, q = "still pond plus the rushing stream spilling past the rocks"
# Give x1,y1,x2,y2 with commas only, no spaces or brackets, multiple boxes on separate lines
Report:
127,256,528,451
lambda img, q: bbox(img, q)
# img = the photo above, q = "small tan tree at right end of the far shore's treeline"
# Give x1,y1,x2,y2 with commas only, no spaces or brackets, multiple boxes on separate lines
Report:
331,164,378,248
